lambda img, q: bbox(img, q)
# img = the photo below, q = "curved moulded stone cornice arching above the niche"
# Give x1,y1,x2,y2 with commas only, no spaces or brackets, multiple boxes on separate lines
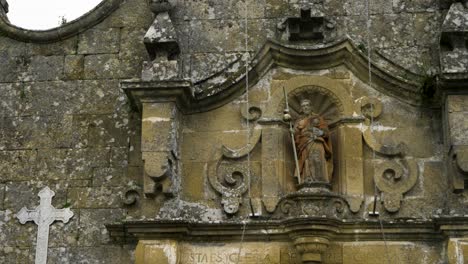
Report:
121,38,424,113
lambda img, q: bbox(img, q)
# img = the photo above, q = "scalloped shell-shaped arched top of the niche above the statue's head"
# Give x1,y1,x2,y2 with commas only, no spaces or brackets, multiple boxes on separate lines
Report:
265,76,360,119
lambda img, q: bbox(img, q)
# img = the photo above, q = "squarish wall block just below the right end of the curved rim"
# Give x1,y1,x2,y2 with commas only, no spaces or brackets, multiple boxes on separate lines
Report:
78,28,120,54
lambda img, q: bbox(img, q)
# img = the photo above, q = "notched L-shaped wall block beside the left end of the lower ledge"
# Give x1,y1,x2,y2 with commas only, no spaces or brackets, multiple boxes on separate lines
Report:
77,209,125,247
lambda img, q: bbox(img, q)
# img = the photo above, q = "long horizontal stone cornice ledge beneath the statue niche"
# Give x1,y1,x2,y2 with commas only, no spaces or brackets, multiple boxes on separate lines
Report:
106,216,468,242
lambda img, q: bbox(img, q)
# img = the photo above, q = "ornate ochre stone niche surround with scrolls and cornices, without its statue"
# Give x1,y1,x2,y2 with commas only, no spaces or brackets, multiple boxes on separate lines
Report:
113,36,464,264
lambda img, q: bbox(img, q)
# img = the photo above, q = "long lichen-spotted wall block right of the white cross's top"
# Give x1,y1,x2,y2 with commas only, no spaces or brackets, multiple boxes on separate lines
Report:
67,187,123,209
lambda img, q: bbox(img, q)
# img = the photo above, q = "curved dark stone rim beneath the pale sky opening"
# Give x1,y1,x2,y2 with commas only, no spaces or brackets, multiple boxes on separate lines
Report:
0,0,124,43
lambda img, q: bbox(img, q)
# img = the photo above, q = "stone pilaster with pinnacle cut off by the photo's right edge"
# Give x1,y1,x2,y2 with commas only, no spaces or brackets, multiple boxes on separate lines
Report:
440,1,468,192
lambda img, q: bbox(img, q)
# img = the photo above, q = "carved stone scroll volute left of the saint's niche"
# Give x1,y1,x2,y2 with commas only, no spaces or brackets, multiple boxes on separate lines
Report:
208,130,261,215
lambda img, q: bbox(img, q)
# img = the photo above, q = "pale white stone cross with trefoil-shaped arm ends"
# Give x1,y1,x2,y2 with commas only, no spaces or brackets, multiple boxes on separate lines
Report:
16,187,73,264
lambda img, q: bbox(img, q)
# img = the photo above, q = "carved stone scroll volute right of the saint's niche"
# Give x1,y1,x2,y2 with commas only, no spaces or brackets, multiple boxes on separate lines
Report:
361,98,418,213
